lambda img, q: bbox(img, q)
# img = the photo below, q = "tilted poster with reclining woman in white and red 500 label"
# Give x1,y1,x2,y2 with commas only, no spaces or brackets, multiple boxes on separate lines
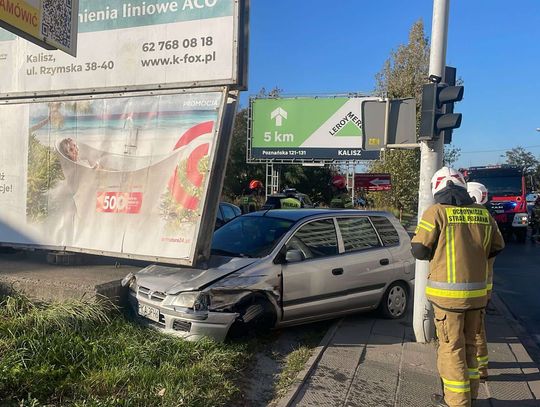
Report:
0,92,224,262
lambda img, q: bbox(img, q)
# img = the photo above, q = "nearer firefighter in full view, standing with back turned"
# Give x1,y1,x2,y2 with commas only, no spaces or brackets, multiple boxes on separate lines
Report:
412,167,504,407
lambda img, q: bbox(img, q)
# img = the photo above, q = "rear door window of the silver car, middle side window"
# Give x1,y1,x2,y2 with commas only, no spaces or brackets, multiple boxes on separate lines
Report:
337,217,381,252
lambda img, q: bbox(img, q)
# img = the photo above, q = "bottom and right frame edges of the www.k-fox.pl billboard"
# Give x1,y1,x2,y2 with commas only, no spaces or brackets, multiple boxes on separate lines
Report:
0,0,251,101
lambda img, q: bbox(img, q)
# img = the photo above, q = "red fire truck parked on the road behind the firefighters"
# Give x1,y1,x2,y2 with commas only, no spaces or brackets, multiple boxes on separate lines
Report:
462,165,529,243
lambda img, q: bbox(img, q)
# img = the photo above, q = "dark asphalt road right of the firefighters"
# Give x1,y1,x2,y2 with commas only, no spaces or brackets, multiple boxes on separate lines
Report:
493,240,540,360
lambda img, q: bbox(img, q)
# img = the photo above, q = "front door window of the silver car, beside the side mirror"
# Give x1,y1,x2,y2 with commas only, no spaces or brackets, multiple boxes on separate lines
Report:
287,219,338,259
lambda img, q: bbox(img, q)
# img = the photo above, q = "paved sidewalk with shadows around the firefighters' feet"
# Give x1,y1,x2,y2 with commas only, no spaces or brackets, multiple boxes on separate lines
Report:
278,298,540,407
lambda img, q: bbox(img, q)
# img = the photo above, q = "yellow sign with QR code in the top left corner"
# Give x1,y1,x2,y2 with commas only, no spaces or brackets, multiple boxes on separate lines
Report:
0,0,79,56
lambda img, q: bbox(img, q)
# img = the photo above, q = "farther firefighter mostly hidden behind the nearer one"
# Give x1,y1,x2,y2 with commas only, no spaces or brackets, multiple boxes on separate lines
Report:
467,182,495,380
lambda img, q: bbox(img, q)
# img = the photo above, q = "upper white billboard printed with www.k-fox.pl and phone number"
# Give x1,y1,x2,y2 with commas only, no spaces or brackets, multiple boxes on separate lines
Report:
0,0,248,98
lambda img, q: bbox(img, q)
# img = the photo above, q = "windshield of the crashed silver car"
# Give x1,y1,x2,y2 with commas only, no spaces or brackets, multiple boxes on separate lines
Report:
212,216,294,257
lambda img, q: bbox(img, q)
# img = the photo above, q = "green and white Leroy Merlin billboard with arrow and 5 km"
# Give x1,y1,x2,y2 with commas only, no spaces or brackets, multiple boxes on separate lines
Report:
248,97,380,162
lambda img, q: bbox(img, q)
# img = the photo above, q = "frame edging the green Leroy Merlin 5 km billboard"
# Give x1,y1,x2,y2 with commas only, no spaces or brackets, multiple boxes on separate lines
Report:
246,92,382,165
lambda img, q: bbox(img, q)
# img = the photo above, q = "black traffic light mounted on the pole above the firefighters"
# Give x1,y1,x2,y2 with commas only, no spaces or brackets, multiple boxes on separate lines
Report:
418,67,464,141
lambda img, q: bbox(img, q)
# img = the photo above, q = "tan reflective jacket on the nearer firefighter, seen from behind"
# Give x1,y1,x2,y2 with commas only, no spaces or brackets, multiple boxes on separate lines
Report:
412,204,504,311
